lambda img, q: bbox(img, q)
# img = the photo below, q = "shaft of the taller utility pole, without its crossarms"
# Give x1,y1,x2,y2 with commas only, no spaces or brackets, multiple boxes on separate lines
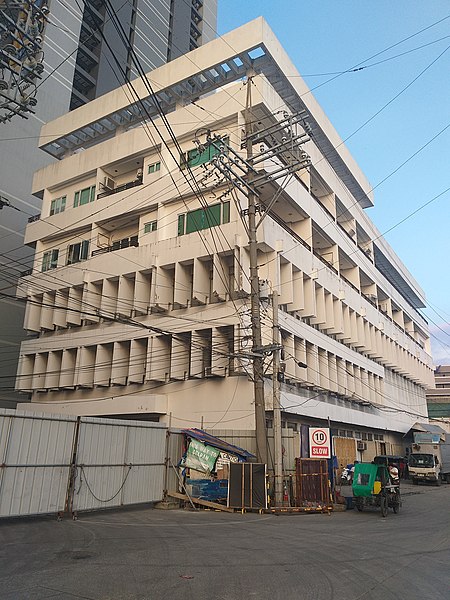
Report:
245,76,267,464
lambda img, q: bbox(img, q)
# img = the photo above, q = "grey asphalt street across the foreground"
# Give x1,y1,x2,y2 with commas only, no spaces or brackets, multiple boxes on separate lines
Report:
0,484,450,600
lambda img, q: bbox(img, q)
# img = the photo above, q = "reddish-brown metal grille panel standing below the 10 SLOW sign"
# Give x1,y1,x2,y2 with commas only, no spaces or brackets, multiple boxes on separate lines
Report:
295,458,331,506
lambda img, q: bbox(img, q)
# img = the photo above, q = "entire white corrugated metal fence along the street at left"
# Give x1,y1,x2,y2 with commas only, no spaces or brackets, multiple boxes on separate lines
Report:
0,409,182,517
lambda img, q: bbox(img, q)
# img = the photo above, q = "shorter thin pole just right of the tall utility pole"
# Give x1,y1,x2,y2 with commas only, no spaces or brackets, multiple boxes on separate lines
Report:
272,290,283,506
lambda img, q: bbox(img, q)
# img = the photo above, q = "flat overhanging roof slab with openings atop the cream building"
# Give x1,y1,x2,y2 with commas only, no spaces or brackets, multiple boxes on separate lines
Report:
40,17,373,208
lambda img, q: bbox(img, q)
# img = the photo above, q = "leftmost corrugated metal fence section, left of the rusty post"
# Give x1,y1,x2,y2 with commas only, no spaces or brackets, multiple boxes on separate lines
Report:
0,409,76,517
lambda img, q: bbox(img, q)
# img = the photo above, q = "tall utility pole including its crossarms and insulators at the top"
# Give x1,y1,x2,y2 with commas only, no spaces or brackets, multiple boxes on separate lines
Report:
205,97,311,468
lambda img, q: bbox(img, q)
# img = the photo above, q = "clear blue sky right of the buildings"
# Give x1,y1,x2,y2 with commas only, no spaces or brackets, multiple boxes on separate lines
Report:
218,0,450,364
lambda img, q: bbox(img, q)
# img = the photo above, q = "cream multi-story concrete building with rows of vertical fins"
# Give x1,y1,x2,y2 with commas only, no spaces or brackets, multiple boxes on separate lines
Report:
17,19,433,460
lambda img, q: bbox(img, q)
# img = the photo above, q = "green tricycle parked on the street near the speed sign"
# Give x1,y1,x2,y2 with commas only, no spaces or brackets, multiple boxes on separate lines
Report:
352,463,401,517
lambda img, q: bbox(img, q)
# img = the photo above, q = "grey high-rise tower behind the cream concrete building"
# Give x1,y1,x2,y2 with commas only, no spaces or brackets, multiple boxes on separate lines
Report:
0,0,217,406
